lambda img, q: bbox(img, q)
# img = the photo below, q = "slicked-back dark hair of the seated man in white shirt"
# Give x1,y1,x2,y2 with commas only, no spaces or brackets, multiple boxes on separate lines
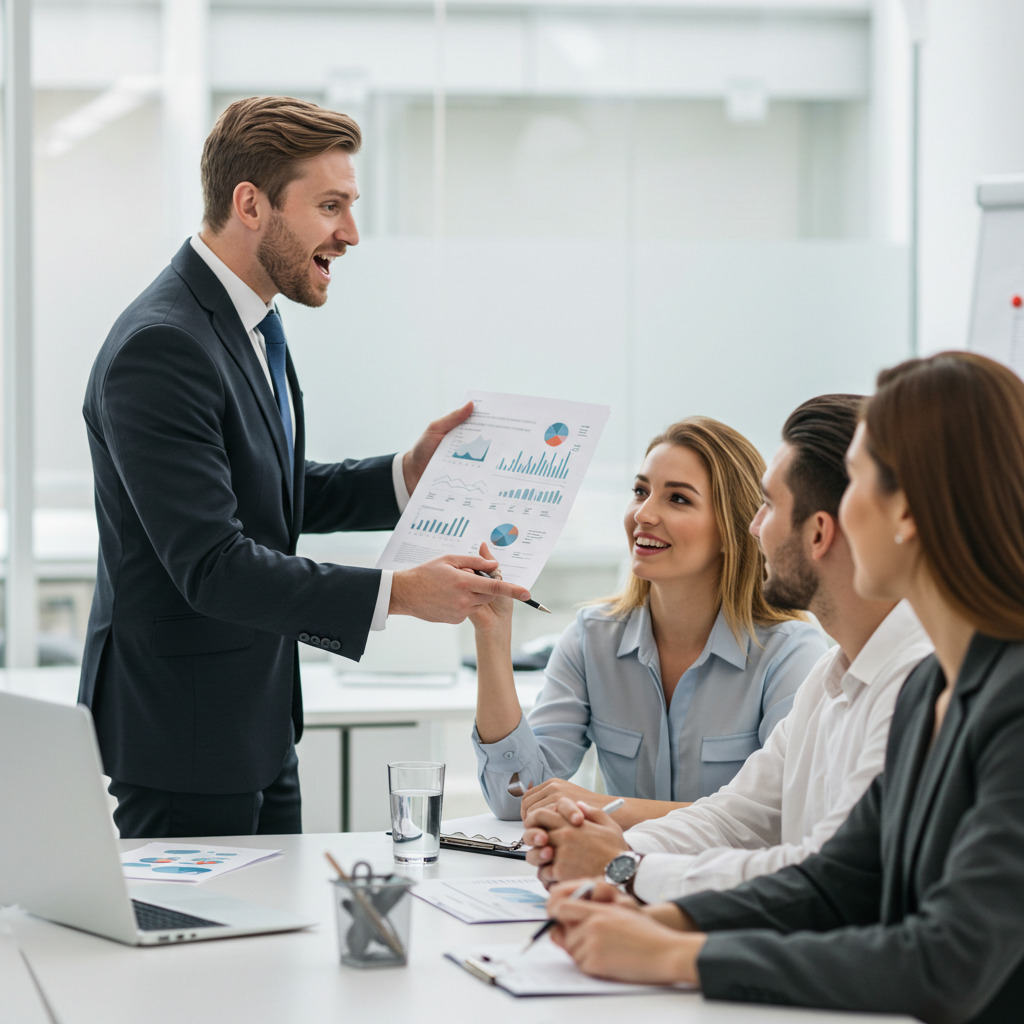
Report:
782,394,864,526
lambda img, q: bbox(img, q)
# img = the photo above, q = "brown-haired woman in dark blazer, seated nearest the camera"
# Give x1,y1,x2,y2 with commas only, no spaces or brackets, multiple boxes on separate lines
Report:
551,352,1024,1024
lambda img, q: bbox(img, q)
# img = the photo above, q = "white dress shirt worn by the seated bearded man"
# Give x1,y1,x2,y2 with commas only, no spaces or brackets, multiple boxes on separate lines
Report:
626,602,932,903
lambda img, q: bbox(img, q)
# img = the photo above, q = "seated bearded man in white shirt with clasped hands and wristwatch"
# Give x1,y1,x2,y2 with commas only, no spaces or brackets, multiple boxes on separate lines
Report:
525,394,932,902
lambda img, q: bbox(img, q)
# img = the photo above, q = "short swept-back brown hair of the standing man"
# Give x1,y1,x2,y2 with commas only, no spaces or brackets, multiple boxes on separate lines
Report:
200,96,362,231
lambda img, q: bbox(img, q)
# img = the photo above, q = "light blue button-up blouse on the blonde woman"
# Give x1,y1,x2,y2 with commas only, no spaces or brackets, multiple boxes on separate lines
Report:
473,605,826,819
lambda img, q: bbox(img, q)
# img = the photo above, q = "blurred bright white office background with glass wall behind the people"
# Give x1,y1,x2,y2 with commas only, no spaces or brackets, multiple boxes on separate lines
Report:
0,0,1024,823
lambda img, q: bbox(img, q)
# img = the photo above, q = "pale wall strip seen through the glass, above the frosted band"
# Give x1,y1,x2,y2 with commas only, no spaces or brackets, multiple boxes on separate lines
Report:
387,97,867,241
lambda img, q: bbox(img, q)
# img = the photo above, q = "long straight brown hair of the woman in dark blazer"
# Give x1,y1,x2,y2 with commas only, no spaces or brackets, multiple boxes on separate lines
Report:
861,352,1024,640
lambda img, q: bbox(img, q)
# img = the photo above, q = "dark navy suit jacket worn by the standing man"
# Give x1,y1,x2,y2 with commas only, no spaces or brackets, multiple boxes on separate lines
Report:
79,242,398,794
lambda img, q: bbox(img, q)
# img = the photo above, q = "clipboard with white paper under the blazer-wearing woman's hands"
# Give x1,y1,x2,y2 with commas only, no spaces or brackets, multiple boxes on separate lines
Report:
444,942,684,996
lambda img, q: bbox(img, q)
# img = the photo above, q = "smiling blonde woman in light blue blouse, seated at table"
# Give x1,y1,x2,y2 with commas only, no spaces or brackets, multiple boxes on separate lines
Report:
471,417,825,827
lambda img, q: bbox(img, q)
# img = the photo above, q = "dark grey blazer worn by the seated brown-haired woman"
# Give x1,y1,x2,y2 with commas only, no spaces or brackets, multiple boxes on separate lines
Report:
677,634,1024,1024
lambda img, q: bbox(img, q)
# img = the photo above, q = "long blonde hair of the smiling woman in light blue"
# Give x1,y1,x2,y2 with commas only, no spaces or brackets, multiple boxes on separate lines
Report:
604,416,805,641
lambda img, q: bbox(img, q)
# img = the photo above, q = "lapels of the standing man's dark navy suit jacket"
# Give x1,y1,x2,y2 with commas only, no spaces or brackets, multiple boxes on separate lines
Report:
171,242,301,520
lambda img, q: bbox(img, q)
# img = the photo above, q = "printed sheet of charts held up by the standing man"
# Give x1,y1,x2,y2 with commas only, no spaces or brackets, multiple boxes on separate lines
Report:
377,391,610,588
